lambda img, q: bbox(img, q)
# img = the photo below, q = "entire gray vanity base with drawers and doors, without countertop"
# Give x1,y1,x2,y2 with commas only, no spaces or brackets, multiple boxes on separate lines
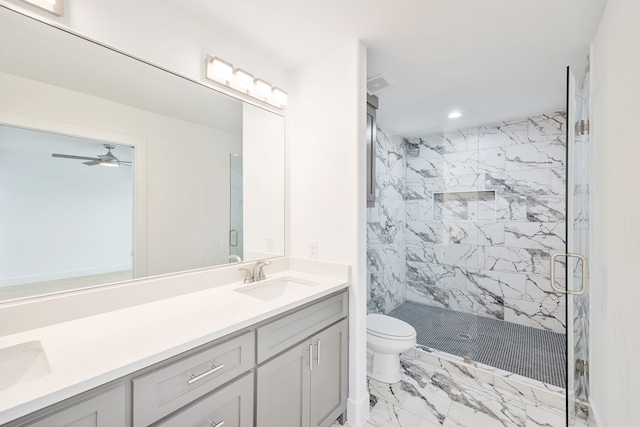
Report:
3,291,348,427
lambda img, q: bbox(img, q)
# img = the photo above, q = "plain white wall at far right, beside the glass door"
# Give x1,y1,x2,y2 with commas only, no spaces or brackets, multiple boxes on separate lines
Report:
589,0,640,427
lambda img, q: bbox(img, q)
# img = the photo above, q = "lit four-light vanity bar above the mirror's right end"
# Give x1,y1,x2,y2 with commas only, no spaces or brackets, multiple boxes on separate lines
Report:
205,56,287,109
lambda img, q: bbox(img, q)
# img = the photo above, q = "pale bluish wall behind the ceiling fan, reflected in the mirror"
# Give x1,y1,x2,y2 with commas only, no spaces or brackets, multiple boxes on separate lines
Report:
0,126,133,286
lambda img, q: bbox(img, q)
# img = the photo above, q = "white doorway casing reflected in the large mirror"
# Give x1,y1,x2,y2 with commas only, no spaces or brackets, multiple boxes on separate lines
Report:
0,111,147,277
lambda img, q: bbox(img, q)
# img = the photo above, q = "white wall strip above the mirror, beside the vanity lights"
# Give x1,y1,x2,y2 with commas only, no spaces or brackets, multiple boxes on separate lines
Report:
0,0,287,92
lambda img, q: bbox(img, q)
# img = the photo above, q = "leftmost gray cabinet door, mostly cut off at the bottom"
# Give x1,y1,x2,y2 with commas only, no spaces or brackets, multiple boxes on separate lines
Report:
20,384,125,427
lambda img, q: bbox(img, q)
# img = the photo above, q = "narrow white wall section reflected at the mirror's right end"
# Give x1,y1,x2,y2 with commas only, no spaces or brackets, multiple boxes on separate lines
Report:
242,104,285,259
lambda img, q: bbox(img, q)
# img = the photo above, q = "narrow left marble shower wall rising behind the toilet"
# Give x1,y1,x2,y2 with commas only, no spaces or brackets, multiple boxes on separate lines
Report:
367,127,406,314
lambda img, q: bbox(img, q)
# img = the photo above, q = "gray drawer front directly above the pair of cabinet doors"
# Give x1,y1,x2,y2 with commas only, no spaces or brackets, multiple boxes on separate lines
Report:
257,291,349,363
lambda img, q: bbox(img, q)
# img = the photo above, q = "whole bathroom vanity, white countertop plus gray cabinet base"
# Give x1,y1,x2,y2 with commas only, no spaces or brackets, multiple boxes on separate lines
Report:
0,260,348,427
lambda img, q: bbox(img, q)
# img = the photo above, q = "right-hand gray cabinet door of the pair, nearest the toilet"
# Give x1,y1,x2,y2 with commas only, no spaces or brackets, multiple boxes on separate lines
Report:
311,320,349,427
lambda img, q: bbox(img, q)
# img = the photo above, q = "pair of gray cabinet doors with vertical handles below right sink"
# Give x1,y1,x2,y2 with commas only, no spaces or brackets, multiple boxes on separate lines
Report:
256,320,348,427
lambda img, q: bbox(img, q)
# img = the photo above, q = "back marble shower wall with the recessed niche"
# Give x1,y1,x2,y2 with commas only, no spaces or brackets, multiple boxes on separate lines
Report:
402,112,566,333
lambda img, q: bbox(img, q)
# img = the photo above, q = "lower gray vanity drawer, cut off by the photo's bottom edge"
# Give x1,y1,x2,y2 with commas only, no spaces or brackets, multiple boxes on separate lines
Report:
154,374,253,427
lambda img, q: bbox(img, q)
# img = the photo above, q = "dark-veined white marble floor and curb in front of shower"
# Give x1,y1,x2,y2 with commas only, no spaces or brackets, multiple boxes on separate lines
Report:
366,356,588,427
